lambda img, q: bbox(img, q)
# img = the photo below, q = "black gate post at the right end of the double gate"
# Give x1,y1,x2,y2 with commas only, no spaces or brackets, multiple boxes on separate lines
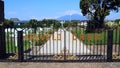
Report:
107,29,113,62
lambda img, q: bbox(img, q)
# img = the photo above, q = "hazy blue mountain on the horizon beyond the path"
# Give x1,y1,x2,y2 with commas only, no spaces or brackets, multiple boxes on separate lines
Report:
57,14,87,20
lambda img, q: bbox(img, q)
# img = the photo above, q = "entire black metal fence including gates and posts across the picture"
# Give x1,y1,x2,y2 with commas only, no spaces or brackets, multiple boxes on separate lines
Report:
0,23,120,62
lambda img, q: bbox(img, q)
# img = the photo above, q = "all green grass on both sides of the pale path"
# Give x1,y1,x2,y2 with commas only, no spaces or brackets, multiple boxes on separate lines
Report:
6,27,120,53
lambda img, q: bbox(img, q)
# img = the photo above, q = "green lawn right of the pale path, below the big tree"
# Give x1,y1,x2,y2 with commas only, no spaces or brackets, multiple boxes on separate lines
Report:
71,27,120,45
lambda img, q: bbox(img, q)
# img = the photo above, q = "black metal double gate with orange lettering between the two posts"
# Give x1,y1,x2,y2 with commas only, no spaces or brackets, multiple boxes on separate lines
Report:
20,24,107,62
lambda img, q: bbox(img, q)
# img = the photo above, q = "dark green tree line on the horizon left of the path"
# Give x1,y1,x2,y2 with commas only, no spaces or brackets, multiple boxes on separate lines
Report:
4,19,61,29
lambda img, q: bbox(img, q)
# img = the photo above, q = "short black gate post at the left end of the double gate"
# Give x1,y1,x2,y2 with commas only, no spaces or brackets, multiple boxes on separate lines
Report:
17,31,24,62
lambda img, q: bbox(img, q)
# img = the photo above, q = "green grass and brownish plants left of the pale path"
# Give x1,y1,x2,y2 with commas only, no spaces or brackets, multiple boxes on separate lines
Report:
6,30,54,53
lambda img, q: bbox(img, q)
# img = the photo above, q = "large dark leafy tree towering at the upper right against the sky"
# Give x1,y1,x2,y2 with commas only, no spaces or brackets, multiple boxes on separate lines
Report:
80,0,120,29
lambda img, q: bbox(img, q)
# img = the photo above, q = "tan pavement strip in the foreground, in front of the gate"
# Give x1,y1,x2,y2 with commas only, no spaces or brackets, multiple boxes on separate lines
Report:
0,62,120,68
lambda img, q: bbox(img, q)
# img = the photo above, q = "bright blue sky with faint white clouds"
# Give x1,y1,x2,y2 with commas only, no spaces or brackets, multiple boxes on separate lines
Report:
4,0,120,20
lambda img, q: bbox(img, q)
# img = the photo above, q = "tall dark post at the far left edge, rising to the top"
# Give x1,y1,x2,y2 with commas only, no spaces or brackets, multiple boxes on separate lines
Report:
0,0,6,59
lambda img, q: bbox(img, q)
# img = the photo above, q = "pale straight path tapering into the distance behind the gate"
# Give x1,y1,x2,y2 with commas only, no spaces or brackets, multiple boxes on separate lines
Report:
36,29,90,55
